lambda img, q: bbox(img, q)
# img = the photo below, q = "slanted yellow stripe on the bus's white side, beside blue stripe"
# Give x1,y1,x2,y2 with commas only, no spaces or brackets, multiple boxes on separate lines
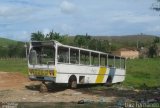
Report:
96,67,107,83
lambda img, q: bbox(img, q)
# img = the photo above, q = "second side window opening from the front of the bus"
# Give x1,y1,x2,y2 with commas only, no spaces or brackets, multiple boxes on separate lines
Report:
70,49,79,64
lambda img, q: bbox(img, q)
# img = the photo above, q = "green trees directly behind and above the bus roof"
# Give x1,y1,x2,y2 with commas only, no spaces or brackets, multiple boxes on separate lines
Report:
31,31,116,52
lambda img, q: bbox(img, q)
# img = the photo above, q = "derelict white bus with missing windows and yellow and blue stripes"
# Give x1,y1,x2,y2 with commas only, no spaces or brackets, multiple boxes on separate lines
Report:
28,41,126,88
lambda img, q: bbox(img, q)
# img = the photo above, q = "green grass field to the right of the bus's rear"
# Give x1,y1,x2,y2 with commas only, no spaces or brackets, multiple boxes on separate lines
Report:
124,58,160,88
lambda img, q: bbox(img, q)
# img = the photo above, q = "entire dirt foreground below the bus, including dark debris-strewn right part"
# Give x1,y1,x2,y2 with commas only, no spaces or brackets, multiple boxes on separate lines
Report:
0,72,160,107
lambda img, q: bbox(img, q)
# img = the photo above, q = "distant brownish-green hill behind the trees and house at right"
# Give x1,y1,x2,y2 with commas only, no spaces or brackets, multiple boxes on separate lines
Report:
93,35,156,48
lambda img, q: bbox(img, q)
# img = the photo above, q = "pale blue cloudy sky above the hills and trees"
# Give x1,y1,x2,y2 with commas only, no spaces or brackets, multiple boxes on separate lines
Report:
0,0,160,41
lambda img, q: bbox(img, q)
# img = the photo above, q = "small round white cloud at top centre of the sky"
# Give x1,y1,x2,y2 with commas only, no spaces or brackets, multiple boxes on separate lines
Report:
60,1,76,14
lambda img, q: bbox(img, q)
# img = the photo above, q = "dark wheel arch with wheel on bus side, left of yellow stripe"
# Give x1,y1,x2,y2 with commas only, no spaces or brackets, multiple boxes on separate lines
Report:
68,75,77,89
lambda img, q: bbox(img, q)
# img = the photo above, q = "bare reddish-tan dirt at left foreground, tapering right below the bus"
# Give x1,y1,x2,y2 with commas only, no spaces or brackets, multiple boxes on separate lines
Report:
0,72,116,102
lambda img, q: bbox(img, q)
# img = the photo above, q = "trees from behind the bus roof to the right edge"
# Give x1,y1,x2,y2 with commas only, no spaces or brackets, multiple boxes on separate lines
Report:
31,30,160,58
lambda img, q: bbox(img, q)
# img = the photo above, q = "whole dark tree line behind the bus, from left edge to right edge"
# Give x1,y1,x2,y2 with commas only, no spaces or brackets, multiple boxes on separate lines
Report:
0,30,160,58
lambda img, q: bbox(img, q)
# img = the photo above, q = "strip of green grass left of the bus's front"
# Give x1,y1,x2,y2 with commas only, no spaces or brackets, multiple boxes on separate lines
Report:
0,59,28,75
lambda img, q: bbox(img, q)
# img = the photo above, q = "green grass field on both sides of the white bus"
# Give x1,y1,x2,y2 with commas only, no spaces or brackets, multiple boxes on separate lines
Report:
0,58,160,88
